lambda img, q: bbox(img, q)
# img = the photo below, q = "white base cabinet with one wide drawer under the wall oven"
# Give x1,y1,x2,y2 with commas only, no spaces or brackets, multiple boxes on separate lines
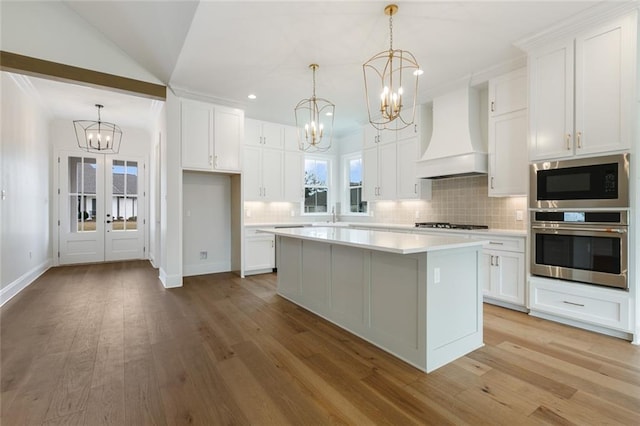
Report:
529,277,633,333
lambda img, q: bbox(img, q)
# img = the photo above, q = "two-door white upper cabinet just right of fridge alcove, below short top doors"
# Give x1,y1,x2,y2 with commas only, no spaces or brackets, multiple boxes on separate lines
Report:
243,146,284,201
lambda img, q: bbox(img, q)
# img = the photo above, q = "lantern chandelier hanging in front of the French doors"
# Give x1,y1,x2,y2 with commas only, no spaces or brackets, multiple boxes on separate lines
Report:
73,104,122,154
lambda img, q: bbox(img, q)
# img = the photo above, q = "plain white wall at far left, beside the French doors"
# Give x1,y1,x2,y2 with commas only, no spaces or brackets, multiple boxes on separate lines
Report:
0,72,52,303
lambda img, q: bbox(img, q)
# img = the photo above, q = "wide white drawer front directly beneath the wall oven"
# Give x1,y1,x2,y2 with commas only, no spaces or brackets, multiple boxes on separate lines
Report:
530,282,630,331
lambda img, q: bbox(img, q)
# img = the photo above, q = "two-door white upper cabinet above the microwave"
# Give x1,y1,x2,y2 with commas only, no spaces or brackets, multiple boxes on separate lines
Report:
529,12,637,160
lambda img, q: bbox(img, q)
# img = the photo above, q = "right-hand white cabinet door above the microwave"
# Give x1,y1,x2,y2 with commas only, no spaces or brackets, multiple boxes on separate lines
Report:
575,19,635,154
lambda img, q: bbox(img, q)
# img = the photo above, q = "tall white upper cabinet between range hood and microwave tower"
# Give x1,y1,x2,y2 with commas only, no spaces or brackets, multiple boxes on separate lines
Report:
488,68,528,197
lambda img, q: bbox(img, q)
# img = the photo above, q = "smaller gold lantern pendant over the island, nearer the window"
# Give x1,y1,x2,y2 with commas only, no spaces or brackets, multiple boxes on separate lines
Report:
295,64,336,152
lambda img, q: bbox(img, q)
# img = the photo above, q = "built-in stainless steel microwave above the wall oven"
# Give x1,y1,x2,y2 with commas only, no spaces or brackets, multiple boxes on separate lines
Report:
529,153,629,209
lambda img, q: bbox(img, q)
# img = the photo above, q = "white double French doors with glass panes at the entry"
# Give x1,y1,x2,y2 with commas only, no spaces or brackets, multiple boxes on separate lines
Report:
58,152,146,264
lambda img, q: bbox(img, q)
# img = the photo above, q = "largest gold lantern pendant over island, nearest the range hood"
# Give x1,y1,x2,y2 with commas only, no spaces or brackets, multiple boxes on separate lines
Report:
362,4,422,130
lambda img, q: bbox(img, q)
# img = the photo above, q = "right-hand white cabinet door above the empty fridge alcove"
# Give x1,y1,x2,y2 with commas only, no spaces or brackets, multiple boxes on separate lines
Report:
213,107,244,172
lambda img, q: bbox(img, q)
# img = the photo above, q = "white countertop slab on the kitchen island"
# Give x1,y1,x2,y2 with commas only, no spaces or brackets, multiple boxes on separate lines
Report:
259,226,487,254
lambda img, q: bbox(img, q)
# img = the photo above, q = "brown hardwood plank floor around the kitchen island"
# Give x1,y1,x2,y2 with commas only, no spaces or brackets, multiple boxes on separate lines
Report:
0,261,640,425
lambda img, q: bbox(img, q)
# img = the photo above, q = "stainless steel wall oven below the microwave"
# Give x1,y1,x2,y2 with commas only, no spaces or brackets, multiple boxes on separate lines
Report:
531,210,628,289
